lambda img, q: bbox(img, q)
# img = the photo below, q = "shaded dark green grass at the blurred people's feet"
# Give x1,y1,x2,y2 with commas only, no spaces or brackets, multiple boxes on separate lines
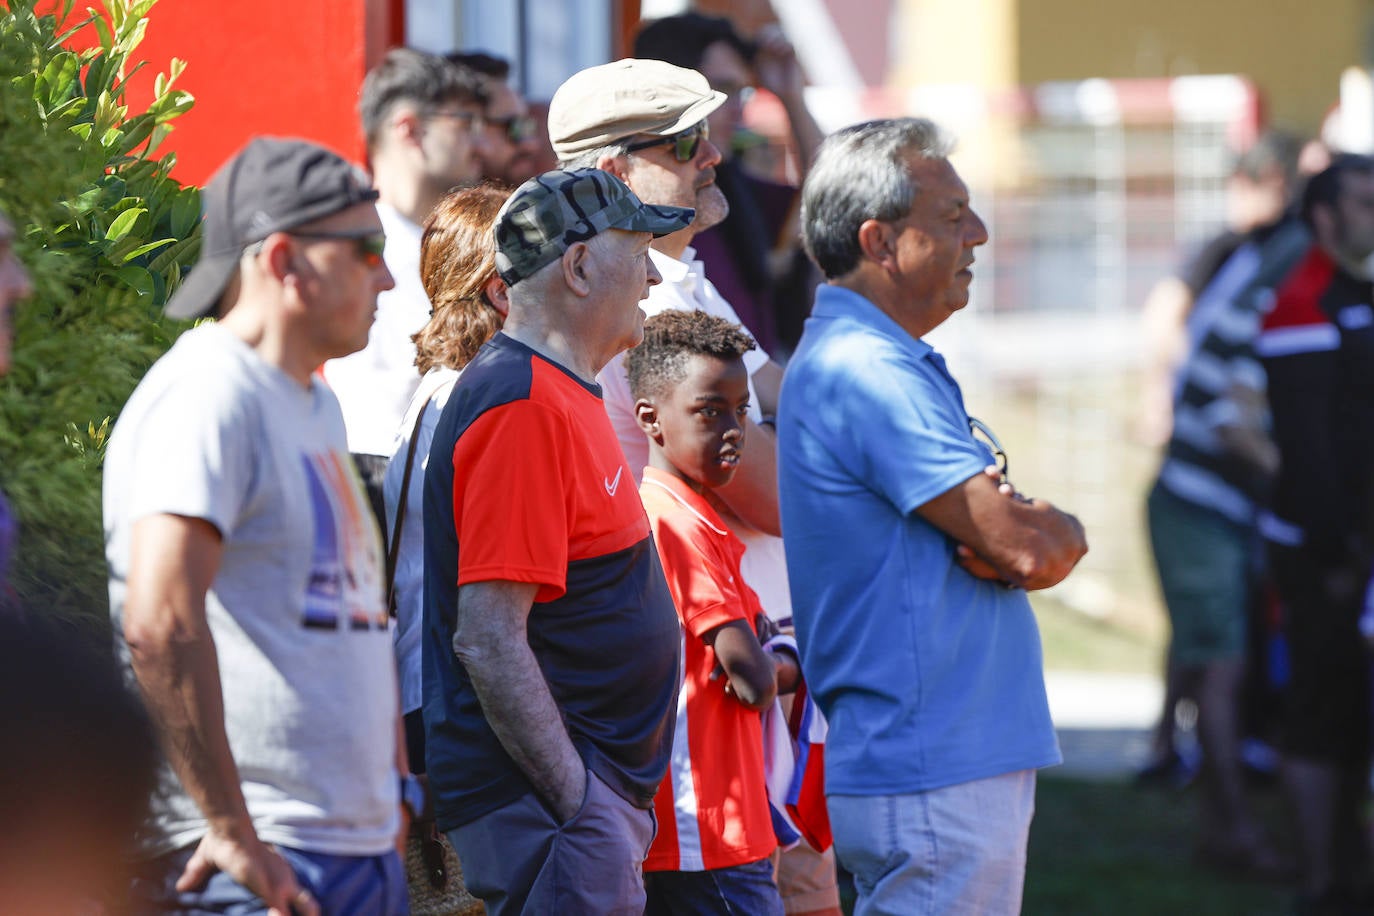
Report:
1022,775,1293,916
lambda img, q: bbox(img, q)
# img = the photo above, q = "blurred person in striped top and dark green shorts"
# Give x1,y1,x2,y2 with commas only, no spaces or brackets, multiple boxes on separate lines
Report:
1139,132,1309,879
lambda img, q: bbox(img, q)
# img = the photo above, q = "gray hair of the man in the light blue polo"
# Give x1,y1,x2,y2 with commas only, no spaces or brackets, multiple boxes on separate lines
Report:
801,118,954,280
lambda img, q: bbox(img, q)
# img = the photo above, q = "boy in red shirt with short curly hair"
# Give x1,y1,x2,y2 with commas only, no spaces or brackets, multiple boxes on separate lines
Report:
625,310,800,916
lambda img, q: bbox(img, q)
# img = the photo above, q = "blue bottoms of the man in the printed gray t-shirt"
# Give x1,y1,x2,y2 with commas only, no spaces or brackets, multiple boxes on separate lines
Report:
129,845,411,916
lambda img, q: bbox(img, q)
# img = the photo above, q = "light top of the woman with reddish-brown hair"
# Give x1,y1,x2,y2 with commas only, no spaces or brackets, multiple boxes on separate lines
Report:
382,367,460,713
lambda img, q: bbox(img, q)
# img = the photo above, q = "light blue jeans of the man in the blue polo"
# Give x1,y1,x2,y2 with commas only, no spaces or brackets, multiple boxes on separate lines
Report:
826,770,1035,916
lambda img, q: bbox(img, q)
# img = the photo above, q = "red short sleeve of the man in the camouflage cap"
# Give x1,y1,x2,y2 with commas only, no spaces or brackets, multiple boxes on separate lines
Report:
453,401,573,602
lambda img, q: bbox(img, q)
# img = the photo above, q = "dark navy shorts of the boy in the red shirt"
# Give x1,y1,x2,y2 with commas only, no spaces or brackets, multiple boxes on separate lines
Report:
644,858,783,916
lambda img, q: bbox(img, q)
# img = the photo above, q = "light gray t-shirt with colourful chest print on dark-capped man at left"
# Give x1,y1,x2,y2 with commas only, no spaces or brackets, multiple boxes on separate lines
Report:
104,324,400,856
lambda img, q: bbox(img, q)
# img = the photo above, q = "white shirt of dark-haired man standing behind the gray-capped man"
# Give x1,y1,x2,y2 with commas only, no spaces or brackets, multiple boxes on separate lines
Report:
324,203,431,456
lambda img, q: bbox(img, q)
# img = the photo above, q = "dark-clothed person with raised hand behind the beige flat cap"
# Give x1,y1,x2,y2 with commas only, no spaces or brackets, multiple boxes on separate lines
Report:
633,12,823,353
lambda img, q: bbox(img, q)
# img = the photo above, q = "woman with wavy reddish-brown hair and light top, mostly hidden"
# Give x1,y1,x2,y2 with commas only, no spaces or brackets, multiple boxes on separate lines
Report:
382,185,510,773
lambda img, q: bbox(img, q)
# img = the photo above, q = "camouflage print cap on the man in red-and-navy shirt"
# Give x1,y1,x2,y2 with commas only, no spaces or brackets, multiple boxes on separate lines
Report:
496,169,697,286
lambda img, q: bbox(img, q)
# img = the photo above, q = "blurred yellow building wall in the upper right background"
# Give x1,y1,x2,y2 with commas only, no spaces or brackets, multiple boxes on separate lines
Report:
1016,0,1374,133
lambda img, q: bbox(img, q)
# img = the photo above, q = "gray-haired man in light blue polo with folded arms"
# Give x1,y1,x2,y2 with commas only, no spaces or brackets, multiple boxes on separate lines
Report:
778,118,1087,916
